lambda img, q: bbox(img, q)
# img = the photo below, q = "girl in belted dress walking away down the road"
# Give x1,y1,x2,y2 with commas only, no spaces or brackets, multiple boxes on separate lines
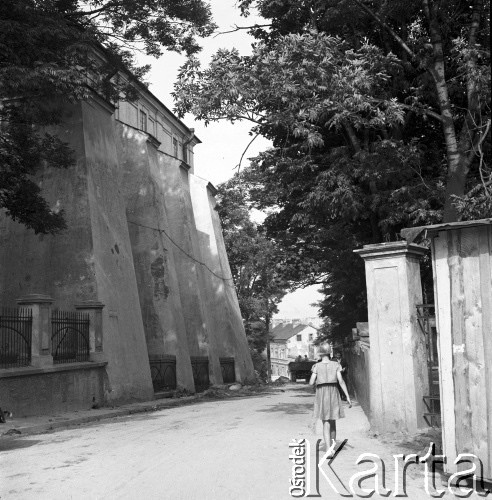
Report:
309,345,352,453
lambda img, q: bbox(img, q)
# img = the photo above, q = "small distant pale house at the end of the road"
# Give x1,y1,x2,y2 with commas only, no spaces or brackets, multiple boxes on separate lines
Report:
270,320,318,380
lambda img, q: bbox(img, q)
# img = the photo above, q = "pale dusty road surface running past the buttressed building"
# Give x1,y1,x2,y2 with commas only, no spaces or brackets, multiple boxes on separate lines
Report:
0,385,472,500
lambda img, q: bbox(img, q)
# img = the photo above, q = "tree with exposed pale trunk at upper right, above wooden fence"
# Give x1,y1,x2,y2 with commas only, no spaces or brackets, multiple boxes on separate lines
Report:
233,0,491,222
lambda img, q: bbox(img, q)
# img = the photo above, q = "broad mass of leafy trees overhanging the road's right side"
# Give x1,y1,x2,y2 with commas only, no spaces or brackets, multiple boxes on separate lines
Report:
175,0,492,340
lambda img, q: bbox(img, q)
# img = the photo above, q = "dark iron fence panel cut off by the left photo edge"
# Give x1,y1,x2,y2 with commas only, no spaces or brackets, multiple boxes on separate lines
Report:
0,308,32,368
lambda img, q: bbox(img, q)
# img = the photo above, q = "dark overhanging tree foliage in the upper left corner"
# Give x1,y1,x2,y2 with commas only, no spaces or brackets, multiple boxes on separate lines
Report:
0,0,214,233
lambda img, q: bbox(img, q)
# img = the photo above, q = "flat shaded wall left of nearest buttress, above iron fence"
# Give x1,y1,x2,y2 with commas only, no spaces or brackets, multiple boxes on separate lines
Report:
0,101,97,308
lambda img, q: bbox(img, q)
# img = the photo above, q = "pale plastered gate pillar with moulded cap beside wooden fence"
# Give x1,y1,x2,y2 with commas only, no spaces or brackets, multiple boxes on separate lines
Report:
355,241,429,432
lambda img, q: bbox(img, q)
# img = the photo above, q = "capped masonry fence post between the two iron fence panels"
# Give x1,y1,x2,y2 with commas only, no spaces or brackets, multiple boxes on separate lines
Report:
17,293,53,368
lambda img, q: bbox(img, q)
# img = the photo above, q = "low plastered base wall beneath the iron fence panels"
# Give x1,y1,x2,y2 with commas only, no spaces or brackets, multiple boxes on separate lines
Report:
0,363,107,417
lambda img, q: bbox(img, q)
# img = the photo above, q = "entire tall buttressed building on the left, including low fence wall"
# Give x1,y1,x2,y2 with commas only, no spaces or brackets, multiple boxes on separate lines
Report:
0,68,254,415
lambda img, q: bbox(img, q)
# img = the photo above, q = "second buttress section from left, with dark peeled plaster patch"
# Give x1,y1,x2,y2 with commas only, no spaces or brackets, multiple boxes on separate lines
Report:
117,124,198,391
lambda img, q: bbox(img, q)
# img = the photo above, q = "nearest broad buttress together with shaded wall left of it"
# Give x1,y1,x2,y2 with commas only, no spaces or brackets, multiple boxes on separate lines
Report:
0,100,153,402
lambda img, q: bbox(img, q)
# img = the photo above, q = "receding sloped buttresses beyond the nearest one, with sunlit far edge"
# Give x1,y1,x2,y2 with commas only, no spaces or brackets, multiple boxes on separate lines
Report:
117,124,254,390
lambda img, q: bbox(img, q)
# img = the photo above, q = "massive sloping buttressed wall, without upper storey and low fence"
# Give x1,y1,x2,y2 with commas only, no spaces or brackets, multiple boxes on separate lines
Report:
0,91,254,410
